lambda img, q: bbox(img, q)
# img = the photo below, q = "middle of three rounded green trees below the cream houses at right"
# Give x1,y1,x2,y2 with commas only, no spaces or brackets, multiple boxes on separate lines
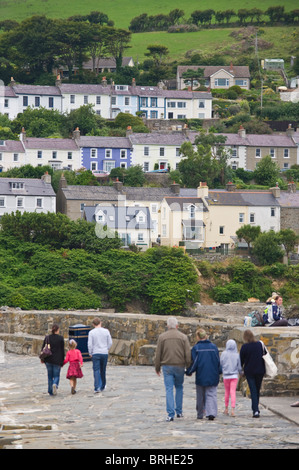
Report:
253,230,283,265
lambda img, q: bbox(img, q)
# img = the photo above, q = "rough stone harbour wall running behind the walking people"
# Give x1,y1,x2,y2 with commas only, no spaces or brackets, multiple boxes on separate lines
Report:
0,303,299,396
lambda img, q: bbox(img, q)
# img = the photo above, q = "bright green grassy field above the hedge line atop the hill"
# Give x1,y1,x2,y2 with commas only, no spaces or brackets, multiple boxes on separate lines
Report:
0,0,298,28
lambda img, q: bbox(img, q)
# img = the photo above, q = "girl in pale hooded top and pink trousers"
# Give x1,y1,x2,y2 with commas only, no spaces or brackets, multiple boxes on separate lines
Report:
220,339,242,416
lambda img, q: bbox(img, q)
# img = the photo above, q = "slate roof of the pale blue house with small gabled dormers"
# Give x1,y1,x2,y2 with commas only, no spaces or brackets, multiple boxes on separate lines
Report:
84,206,153,230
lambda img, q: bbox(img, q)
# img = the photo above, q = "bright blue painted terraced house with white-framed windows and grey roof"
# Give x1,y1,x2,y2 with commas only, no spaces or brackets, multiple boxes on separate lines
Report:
77,136,132,173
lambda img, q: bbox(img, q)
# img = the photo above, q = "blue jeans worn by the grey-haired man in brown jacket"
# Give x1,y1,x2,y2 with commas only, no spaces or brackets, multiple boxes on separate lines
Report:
162,366,185,418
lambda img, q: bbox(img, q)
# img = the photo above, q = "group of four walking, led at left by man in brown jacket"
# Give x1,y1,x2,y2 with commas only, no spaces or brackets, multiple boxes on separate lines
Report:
155,317,265,421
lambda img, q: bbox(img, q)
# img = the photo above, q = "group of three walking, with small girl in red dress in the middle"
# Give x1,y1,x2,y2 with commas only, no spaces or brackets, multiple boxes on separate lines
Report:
42,317,112,395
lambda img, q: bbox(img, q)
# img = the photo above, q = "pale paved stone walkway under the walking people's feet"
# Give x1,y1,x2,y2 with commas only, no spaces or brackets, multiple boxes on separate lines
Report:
0,354,299,451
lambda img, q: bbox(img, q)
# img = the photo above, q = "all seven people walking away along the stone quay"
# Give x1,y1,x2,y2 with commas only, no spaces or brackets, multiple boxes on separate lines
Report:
42,317,276,421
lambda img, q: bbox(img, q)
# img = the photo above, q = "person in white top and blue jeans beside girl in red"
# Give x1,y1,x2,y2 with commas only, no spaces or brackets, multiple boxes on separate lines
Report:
87,317,112,393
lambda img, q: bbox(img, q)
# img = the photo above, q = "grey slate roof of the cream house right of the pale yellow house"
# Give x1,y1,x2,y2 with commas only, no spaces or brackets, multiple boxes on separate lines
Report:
207,190,279,207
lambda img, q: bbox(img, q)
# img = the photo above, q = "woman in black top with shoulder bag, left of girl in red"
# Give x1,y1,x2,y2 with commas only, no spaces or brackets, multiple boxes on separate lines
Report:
41,324,65,395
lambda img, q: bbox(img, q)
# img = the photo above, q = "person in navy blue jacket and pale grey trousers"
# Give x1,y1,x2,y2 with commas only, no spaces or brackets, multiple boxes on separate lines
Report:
186,329,222,420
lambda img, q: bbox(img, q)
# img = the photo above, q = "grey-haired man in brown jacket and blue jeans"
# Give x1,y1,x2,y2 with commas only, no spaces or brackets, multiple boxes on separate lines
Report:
155,317,191,421
